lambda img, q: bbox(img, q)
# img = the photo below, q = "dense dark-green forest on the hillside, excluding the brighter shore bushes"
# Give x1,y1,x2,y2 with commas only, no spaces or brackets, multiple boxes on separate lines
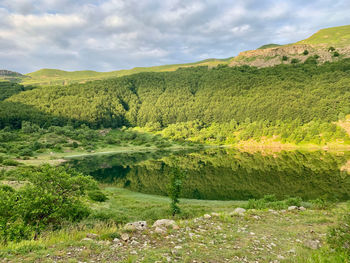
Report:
0,59,350,131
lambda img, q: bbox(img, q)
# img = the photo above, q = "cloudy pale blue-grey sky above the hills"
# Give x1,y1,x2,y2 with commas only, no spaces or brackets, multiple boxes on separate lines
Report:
0,0,350,73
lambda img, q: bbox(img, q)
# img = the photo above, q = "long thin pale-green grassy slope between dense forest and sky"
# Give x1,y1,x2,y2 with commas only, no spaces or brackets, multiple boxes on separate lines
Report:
22,58,230,85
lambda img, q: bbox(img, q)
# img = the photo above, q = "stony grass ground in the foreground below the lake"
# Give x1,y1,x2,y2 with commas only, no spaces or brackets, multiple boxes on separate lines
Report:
0,186,348,262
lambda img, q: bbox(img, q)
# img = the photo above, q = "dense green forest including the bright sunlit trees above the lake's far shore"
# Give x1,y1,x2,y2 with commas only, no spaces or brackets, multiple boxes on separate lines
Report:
0,56,350,144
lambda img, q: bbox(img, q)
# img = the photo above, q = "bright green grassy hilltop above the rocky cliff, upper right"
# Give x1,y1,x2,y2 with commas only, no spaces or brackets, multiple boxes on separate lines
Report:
296,25,350,47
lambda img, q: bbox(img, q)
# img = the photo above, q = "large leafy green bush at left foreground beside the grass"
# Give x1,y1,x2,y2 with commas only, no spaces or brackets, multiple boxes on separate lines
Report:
0,165,97,243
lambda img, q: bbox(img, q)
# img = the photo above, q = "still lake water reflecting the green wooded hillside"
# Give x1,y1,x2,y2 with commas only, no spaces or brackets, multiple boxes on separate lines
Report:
70,148,350,200
